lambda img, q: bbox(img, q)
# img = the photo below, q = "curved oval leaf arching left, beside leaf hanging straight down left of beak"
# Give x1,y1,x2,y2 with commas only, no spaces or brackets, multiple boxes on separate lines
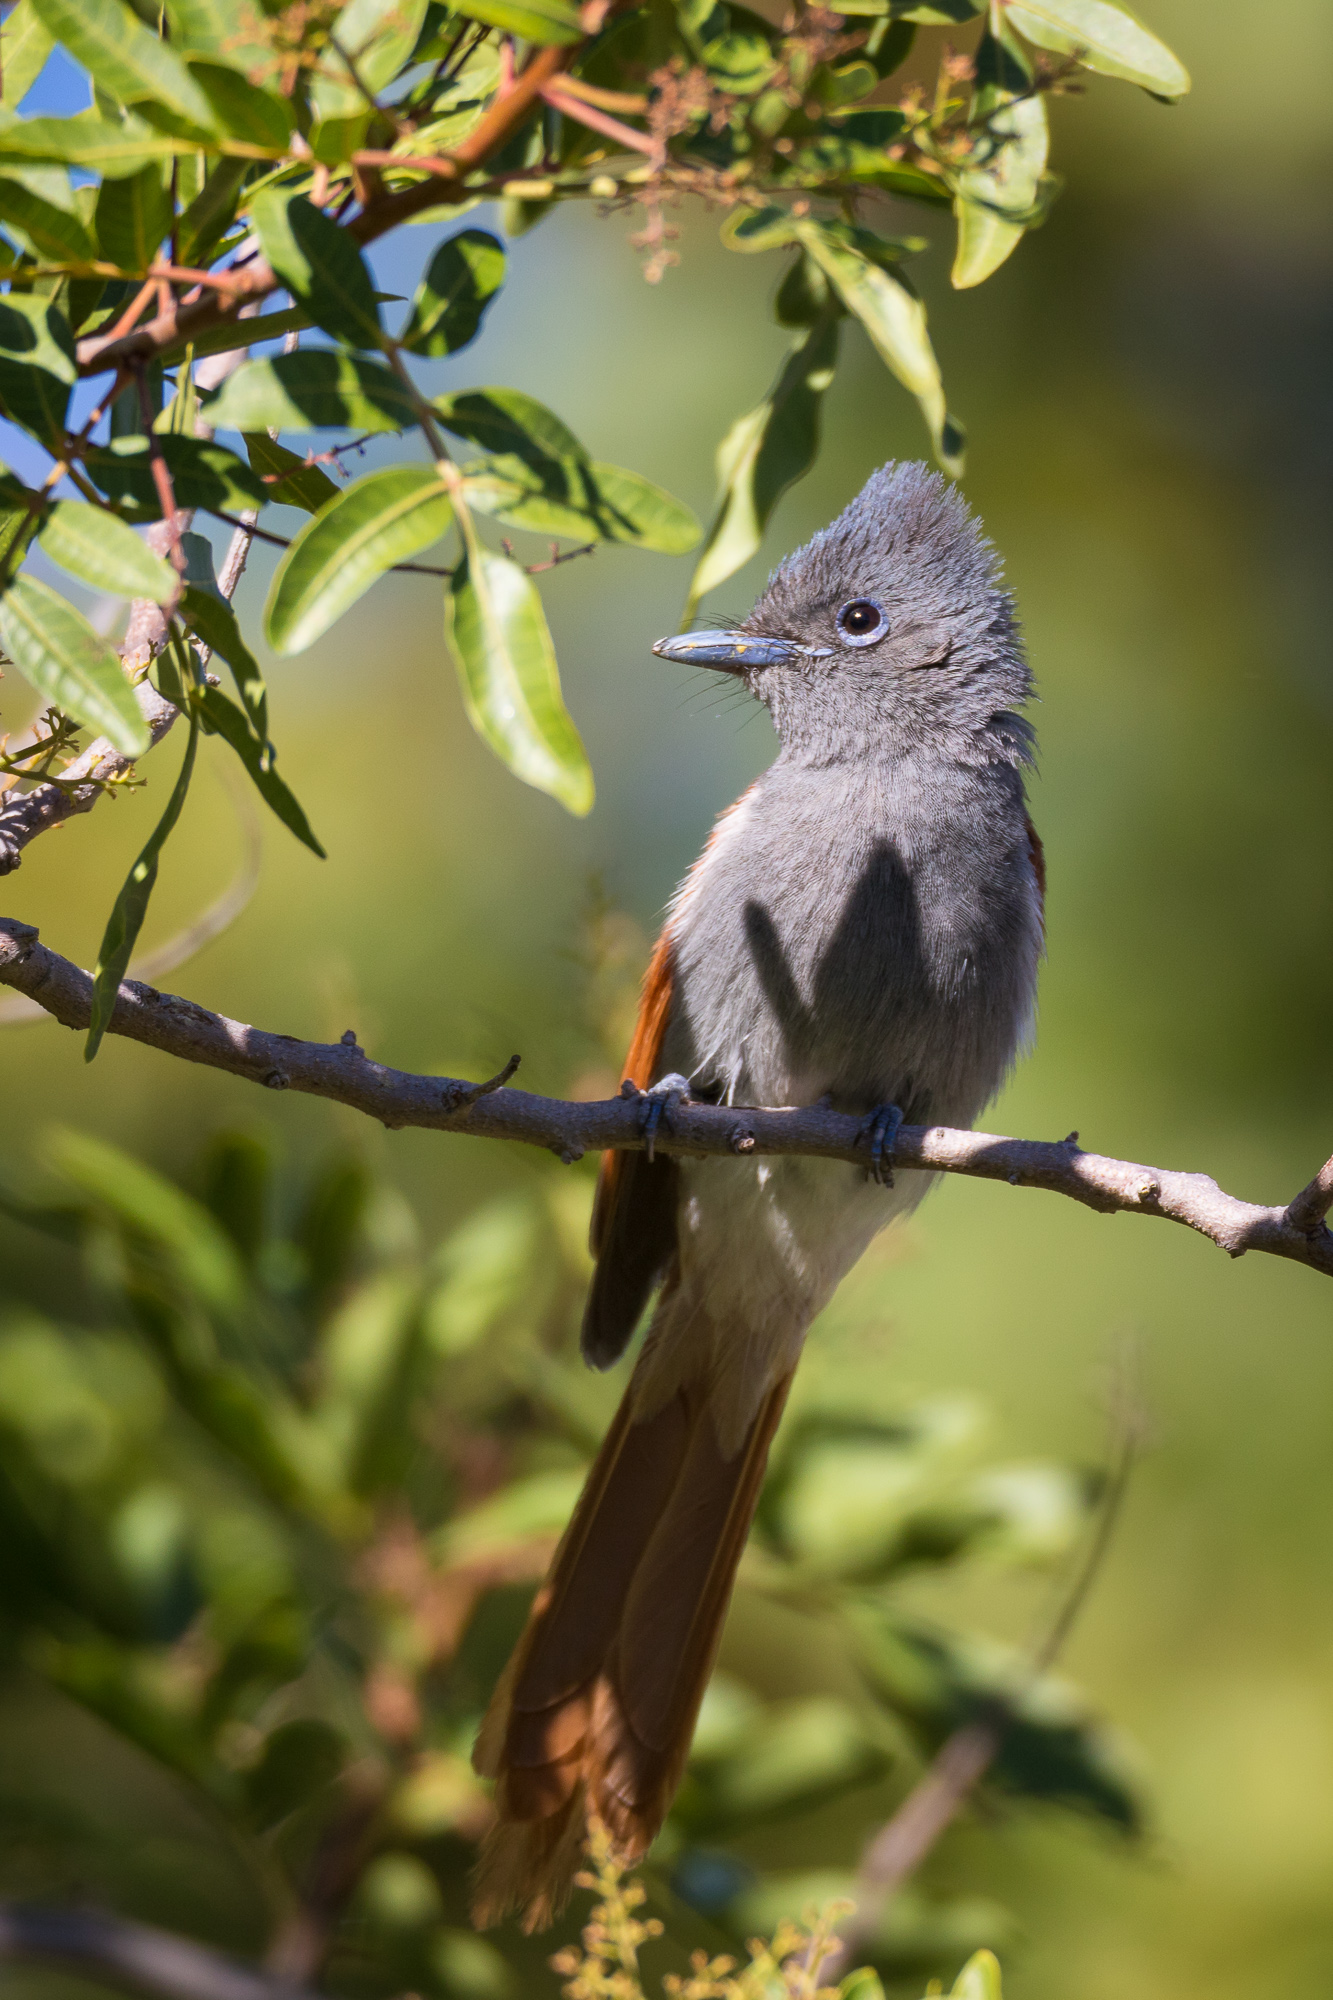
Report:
264,466,454,654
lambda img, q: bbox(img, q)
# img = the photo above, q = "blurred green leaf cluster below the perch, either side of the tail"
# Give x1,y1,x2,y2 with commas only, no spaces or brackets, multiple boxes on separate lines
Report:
0,1132,1139,2000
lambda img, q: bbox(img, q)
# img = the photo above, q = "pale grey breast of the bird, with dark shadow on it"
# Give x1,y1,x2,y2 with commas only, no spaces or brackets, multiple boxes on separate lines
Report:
662,758,1041,1124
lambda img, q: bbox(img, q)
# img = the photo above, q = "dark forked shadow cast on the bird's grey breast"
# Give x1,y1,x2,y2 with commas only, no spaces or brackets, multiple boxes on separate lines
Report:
745,840,931,1124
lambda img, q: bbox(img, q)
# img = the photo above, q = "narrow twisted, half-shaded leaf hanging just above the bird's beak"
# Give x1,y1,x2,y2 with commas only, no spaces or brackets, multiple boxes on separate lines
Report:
685,310,839,618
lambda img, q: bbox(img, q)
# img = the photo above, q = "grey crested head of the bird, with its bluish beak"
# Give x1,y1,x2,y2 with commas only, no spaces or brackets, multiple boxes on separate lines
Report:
654,464,1033,764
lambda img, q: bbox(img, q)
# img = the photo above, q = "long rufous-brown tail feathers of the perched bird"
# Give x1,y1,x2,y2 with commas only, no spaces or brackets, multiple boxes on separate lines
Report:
472,1374,791,1930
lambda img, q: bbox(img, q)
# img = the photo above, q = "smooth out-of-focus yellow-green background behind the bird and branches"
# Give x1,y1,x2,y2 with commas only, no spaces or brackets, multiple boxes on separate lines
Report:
0,0,1333,2000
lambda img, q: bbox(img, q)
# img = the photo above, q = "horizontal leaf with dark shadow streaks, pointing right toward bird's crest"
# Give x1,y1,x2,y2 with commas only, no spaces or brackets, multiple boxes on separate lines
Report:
462,452,699,556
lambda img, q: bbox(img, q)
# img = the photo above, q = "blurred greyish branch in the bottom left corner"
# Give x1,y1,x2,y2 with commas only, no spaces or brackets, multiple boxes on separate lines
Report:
0,1902,316,2000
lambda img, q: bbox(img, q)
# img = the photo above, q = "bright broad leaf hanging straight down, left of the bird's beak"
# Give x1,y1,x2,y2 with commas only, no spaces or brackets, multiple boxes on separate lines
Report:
444,538,592,816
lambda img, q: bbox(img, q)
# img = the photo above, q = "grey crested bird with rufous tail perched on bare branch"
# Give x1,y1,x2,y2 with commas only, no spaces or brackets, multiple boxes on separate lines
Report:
472,462,1045,1930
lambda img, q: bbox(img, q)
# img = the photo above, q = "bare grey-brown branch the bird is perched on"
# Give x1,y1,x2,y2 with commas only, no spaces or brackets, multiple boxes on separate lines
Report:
0,918,1333,1278
